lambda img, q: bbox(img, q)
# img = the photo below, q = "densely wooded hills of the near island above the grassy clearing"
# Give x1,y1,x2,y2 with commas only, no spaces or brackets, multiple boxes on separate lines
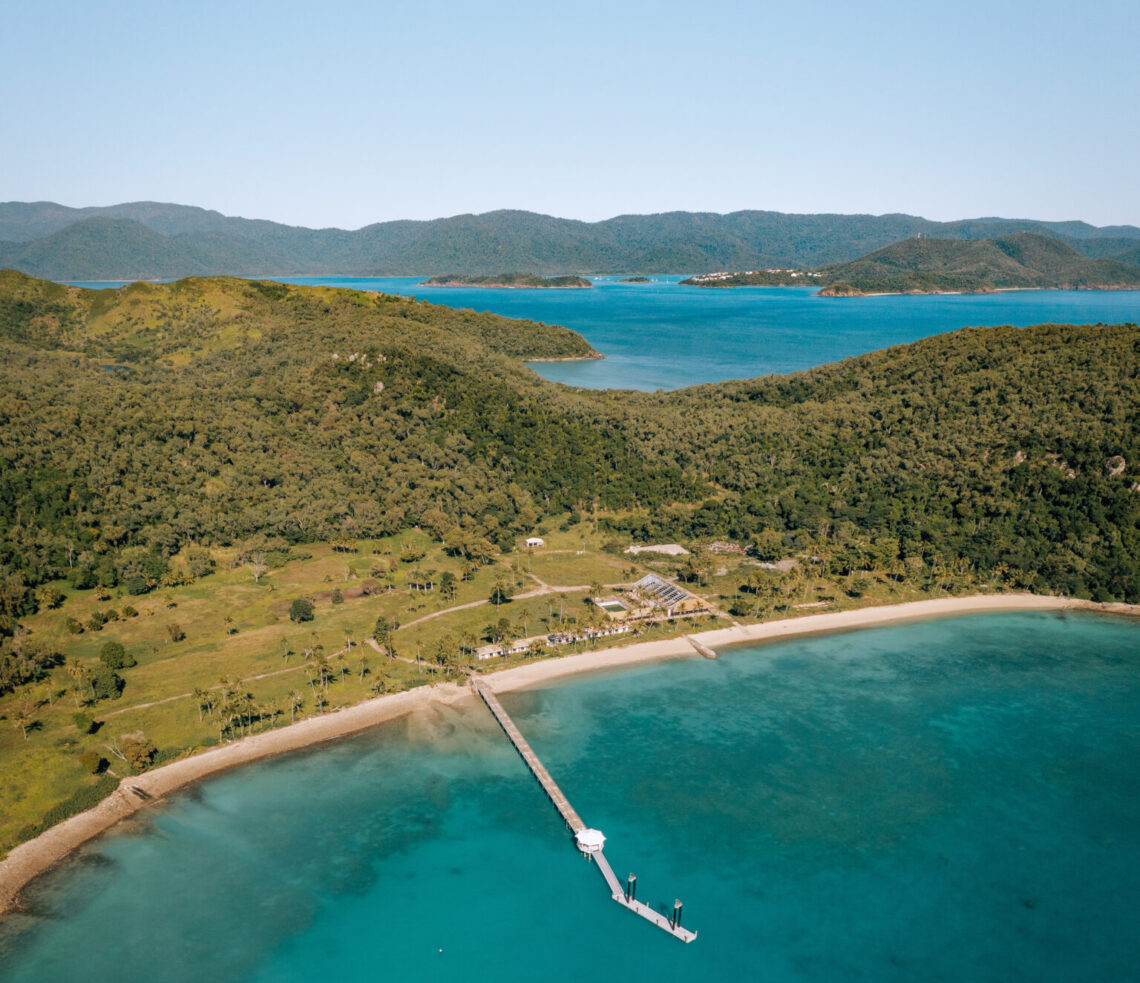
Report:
0,271,1140,632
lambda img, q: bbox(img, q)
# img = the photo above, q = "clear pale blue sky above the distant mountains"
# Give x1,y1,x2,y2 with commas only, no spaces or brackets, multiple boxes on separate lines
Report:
0,0,1140,228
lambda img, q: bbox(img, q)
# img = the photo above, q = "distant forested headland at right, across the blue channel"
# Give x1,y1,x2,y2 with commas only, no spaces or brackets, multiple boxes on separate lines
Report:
817,233,1140,296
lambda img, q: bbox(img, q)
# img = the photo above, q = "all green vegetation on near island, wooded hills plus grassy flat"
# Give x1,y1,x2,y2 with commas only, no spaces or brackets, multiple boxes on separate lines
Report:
0,273,1140,845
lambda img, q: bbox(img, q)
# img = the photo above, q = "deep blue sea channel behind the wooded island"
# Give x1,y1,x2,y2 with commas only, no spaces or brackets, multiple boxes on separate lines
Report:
68,276,1140,390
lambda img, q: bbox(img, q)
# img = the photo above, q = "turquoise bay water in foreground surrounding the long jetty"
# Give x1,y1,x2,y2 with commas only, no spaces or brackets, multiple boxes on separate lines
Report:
0,614,1140,983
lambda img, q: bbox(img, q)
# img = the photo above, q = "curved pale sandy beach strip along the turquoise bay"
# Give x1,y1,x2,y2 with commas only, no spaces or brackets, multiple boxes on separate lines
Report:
0,594,1140,919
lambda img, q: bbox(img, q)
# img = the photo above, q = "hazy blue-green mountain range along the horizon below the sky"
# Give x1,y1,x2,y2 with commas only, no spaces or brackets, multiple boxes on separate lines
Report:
0,202,1140,281
